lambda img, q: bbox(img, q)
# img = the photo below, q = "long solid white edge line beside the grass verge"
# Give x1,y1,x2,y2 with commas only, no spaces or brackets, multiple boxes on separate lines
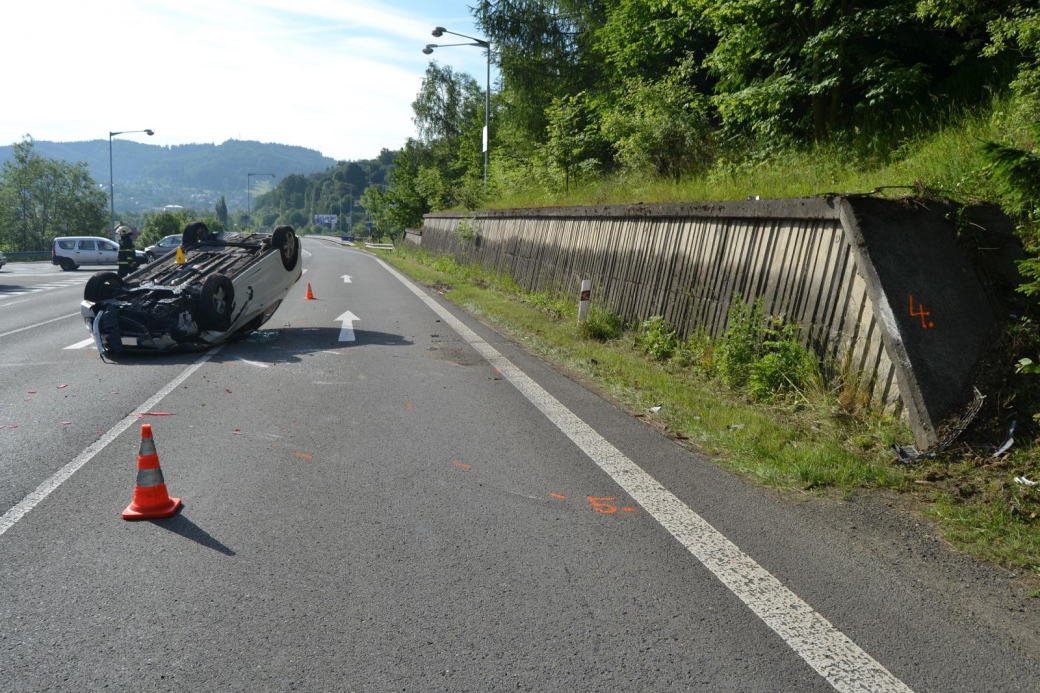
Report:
375,258,910,693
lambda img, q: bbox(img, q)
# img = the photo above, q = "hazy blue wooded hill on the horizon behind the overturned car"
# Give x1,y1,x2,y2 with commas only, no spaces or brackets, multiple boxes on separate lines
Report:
0,137,336,212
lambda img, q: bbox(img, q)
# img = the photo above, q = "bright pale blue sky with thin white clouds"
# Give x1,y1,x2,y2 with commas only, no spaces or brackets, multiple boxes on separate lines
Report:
0,0,496,159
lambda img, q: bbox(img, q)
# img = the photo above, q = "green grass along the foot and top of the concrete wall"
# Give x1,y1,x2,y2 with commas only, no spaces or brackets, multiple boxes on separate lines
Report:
374,102,1040,578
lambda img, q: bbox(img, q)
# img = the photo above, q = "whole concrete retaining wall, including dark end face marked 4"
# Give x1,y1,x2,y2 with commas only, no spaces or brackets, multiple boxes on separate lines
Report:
421,197,994,446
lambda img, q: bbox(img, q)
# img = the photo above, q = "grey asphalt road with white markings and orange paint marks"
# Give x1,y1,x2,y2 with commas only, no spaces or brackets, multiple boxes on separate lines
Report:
0,239,1040,691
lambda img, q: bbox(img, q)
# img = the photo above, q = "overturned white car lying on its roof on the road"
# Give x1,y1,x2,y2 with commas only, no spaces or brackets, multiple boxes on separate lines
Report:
80,222,303,354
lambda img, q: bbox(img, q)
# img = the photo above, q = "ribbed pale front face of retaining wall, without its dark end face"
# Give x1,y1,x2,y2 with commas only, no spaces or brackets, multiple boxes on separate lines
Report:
422,198,994,444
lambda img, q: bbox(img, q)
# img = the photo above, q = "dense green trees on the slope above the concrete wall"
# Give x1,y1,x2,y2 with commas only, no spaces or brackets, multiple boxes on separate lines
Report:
355,0,1040,250
